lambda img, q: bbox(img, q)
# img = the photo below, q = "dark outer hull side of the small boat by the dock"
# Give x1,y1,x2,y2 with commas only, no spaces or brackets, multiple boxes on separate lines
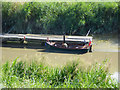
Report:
45,42,89,53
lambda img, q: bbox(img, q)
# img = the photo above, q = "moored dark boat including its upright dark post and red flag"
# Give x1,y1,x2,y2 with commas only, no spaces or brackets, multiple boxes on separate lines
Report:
45,29,92,53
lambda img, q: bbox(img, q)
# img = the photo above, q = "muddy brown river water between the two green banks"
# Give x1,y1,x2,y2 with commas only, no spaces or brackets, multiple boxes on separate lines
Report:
0,35,120,73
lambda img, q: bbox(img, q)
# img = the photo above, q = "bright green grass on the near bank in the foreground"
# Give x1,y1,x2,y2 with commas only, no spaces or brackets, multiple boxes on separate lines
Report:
1,59,118,88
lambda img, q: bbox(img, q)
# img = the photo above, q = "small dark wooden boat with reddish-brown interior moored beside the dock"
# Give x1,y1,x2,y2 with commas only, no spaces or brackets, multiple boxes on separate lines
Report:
46,42,92,53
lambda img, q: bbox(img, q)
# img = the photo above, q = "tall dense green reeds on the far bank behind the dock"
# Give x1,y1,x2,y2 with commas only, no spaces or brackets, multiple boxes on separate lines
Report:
2,2,120,35
